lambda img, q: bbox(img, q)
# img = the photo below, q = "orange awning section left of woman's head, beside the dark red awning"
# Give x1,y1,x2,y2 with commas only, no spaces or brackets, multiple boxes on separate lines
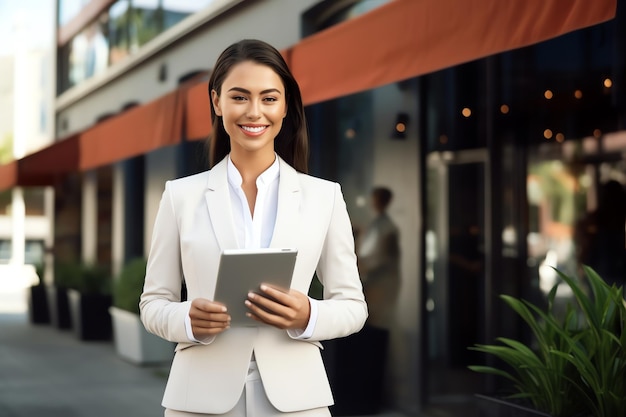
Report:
79,89,185,170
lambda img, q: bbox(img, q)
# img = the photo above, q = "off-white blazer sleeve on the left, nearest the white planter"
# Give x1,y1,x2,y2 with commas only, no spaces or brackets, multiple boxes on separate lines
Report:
139,181,190,343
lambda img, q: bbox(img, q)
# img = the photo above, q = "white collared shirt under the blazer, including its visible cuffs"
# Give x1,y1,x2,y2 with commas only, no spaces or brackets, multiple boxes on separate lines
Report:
185,155,318,343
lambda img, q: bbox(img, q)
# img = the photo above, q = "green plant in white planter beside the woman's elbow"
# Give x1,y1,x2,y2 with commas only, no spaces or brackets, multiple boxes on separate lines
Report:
109,258,174,365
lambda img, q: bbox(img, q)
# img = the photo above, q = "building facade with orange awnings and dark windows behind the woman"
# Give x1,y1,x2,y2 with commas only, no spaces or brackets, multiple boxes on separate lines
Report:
4,0,626,415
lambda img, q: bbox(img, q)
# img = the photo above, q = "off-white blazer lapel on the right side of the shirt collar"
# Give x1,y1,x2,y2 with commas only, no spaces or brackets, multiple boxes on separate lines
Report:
270,157,302,248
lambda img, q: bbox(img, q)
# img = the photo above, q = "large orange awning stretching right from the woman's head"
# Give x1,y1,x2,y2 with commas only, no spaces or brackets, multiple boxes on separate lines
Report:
289,0,616,104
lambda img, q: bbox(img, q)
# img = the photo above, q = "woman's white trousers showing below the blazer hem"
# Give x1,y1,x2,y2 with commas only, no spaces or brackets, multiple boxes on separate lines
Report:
164,361,330,417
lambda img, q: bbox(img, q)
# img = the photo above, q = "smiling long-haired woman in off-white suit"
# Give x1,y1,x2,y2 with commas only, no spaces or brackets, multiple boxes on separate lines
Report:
140,40,367,417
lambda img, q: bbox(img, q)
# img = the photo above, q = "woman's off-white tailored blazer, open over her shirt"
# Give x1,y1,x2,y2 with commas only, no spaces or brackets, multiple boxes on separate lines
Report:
140,159,367,414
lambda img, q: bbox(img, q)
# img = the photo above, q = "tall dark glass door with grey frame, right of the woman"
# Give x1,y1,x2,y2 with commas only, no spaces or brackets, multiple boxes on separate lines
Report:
424,149,488,416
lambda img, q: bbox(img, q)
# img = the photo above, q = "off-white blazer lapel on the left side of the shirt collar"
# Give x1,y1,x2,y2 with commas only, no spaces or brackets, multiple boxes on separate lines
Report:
204,158,238,250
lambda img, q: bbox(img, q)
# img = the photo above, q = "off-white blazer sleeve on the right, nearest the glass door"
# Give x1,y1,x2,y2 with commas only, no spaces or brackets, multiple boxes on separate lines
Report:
309,184,368,340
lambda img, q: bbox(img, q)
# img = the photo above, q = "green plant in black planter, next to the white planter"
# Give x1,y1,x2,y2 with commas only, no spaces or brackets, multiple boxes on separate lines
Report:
67,263,113,340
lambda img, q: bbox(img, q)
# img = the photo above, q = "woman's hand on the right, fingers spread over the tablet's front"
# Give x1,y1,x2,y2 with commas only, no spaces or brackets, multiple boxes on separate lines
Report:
246,284,311,330
